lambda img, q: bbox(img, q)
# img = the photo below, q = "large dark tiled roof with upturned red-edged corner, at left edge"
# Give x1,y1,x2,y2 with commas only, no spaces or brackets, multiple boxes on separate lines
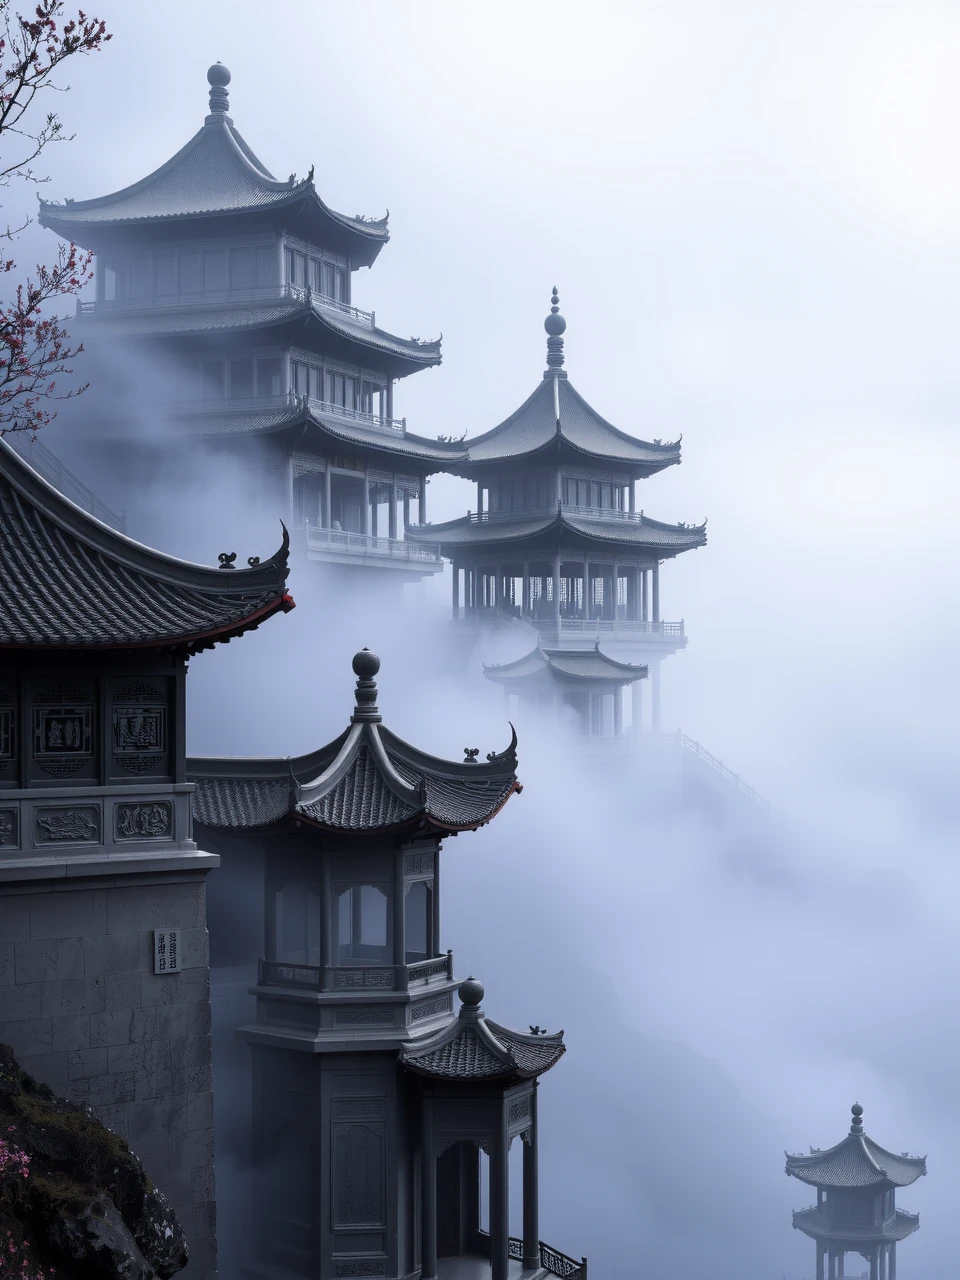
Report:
0,440,293,653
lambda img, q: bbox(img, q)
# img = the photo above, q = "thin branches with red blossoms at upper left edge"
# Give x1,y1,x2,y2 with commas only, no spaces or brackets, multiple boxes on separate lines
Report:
0,0,110,435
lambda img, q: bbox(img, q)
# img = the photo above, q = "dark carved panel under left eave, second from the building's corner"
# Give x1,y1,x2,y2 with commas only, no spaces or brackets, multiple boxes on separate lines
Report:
31,680,97,782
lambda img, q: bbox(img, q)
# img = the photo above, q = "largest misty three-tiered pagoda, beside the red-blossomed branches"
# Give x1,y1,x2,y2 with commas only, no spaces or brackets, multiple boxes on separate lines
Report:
40,63,462,579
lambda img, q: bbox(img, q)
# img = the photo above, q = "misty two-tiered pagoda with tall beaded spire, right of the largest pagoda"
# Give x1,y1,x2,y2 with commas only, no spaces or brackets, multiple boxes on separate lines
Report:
408,289,707,728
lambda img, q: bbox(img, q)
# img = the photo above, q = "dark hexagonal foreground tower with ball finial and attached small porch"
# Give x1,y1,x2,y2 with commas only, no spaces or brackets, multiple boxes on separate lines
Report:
188,649,586,1280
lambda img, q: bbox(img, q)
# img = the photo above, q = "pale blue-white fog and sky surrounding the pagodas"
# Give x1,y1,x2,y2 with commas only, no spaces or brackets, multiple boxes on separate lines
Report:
8,0,960,1280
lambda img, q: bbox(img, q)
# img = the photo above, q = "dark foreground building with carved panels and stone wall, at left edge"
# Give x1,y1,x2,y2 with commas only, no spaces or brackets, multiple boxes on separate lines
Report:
0,440,293,1280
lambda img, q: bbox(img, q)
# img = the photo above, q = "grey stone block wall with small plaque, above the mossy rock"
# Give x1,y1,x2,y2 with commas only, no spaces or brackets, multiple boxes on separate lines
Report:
0,873,216,1280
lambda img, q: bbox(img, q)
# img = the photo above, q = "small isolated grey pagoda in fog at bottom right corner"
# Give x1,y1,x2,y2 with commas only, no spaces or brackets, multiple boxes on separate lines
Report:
786,1103,927,1280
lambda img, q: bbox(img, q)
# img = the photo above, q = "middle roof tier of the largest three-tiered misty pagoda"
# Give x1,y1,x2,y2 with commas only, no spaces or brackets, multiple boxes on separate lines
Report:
82,293,442,372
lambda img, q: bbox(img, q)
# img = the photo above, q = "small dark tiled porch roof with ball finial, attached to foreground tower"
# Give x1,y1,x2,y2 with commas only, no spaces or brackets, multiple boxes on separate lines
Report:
399,998,566,1082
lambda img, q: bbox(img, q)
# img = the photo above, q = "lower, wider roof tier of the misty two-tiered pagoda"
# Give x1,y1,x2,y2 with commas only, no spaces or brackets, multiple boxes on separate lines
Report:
404,504,707,557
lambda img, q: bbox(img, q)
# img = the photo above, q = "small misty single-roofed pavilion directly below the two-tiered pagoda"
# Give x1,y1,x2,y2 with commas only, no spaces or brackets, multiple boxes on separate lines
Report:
484,640,646,737
